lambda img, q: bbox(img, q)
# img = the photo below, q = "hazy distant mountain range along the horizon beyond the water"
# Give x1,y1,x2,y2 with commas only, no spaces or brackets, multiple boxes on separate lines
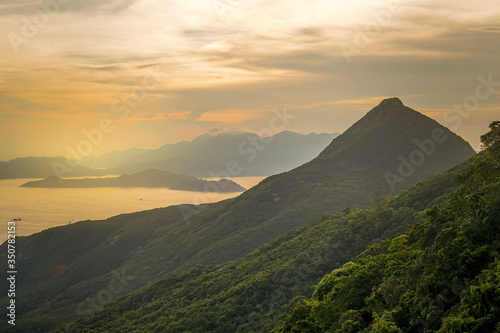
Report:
0,129,338,179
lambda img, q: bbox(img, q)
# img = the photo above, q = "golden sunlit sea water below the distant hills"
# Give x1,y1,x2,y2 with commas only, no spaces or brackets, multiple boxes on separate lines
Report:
0,177,265,242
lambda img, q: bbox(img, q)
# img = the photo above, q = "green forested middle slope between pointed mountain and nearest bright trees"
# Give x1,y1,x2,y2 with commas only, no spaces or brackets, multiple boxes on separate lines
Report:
54,137,472,332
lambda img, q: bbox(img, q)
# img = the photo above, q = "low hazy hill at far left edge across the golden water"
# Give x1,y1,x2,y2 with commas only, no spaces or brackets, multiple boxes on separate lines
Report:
0,157,106,179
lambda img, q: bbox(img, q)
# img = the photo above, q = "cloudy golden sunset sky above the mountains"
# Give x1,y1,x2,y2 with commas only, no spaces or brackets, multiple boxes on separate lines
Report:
0,0,500,160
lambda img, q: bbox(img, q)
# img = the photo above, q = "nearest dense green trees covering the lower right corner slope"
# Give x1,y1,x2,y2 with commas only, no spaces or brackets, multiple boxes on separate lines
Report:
279,122,500,333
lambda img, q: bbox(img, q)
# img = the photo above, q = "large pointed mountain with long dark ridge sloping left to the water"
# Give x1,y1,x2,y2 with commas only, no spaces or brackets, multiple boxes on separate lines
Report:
0,99,474,332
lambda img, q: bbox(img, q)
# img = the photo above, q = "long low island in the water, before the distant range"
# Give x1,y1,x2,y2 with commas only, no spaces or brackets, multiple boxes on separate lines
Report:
21,170,245,193
